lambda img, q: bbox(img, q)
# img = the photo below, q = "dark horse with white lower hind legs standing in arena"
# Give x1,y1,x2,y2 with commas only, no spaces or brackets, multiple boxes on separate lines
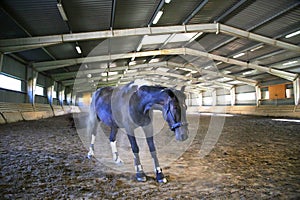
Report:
87,82,189,183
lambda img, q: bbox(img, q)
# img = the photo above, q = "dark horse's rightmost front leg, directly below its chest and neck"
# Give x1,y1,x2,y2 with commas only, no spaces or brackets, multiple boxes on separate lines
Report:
143,124,167,183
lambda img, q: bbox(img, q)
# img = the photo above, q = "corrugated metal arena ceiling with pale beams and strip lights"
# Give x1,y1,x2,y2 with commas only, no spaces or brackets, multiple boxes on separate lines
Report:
0,0,300,92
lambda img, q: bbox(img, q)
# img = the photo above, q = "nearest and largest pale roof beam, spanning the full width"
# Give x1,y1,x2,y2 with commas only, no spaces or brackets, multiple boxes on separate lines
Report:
0,23,300,53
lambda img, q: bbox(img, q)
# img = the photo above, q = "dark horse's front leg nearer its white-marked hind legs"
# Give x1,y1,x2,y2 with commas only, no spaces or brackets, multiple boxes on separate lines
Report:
127,131,147,182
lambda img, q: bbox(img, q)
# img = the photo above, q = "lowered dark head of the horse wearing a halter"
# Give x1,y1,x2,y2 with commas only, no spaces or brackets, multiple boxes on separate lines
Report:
162,88,189,141
